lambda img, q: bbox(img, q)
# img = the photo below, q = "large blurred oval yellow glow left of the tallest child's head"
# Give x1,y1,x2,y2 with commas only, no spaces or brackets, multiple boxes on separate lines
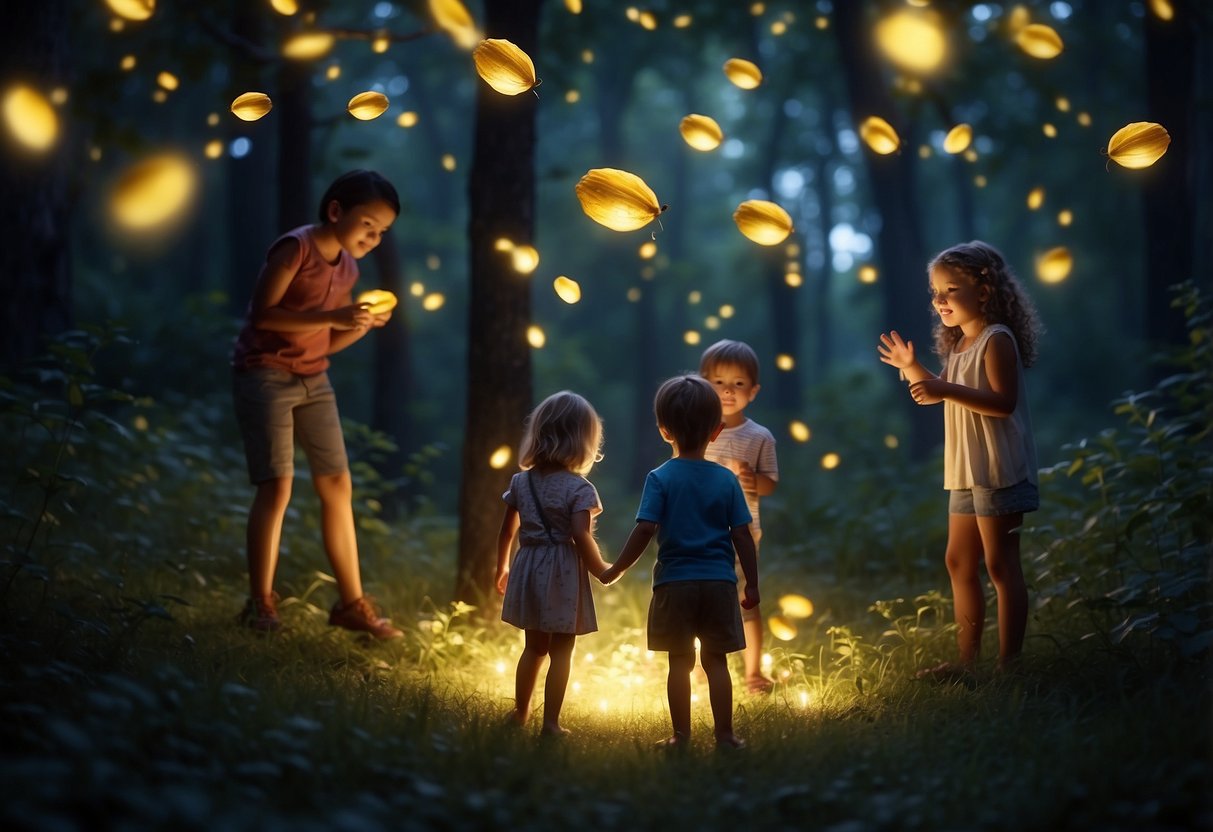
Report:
109,154,198,232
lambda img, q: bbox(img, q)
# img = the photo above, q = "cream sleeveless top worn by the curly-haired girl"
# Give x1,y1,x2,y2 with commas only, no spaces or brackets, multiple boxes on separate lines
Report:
944,324,1037,491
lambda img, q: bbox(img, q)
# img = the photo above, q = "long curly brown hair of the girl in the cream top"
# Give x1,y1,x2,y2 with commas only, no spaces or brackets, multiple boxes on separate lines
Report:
927,240,1044,367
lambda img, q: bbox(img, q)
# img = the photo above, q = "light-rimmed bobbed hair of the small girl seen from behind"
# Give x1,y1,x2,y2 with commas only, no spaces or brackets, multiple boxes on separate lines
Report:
518,391,603,477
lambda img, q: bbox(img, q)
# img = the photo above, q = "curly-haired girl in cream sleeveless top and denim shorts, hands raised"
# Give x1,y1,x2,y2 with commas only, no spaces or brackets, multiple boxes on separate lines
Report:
877,240,1041,679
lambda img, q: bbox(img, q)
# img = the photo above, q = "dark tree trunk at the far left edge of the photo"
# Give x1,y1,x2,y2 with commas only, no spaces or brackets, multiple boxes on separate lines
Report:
0,0,73,371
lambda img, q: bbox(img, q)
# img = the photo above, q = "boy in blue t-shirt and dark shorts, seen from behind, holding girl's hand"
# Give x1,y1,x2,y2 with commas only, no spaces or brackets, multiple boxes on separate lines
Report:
599,375,758,748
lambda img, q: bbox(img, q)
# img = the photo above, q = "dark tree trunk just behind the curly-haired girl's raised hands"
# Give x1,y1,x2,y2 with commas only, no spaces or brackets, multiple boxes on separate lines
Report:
835,2,943,458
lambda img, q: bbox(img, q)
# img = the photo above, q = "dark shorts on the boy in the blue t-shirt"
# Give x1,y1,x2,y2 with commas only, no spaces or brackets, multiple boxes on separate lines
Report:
649,581,746,654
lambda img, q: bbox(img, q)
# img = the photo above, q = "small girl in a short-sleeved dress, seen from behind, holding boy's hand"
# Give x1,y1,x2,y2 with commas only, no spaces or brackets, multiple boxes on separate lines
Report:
497,391,607,735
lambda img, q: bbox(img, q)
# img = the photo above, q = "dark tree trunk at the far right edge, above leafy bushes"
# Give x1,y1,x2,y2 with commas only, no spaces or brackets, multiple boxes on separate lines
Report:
1139,0,1198,363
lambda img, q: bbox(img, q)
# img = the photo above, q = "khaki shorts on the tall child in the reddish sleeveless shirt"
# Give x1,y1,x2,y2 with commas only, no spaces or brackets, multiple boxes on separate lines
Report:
232,367,349,485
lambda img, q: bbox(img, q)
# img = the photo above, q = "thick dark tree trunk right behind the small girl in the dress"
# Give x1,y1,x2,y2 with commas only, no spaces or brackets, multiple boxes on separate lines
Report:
455,0,541,604
